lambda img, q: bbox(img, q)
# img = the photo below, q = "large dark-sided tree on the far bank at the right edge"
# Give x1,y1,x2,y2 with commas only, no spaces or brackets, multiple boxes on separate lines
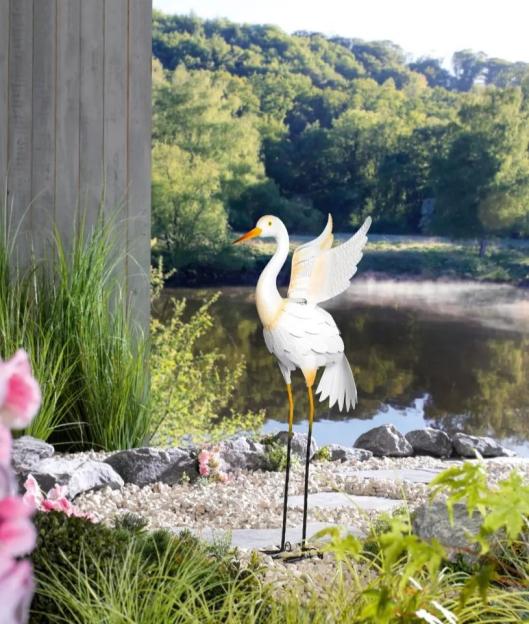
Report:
433,88,529,251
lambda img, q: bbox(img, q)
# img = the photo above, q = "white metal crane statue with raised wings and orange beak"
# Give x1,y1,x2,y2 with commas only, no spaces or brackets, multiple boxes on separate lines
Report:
234,215,371,552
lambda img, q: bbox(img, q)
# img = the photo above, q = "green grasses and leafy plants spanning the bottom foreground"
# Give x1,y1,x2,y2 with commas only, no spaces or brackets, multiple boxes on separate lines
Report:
33,462,529,624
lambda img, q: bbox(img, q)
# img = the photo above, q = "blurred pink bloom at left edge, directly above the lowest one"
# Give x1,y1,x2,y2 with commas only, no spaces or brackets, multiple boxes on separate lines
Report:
0,496,36,557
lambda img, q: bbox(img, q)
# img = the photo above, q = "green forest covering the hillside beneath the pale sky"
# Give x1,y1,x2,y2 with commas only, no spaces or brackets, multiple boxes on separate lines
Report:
153,12,529,268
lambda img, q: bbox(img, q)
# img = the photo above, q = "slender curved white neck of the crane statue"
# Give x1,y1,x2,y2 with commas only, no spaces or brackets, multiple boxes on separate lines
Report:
255,224,289,328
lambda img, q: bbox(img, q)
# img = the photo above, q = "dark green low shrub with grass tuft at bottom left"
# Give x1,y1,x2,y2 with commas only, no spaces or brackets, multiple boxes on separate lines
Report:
31,512,265,624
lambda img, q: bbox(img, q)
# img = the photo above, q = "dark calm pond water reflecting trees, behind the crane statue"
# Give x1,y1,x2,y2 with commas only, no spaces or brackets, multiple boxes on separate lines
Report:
167,279,529,456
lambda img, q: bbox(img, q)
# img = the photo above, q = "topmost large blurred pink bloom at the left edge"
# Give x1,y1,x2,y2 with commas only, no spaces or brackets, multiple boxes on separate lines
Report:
0,349,41,429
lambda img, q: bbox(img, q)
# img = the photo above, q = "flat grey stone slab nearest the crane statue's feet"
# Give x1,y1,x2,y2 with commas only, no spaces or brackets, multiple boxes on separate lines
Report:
174,522,363,550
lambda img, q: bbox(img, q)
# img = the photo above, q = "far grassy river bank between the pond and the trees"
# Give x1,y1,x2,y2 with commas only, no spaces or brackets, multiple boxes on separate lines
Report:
168,235,529,287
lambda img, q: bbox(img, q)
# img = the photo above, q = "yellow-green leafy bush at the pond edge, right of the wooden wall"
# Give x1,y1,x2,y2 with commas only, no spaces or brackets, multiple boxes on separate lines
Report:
151,268,264,444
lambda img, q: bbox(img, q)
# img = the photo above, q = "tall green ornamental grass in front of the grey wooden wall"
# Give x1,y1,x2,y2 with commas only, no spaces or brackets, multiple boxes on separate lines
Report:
0,211,151,450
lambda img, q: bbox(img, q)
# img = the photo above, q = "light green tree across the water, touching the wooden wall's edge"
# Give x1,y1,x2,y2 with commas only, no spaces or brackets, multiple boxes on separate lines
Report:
153,67,264,254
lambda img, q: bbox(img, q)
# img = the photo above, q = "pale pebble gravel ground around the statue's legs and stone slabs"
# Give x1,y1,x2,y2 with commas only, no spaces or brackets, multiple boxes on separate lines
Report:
75,457,529,530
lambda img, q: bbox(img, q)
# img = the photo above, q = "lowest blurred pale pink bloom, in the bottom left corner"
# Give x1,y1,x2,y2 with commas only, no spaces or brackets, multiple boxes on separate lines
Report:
0,555,33,624
